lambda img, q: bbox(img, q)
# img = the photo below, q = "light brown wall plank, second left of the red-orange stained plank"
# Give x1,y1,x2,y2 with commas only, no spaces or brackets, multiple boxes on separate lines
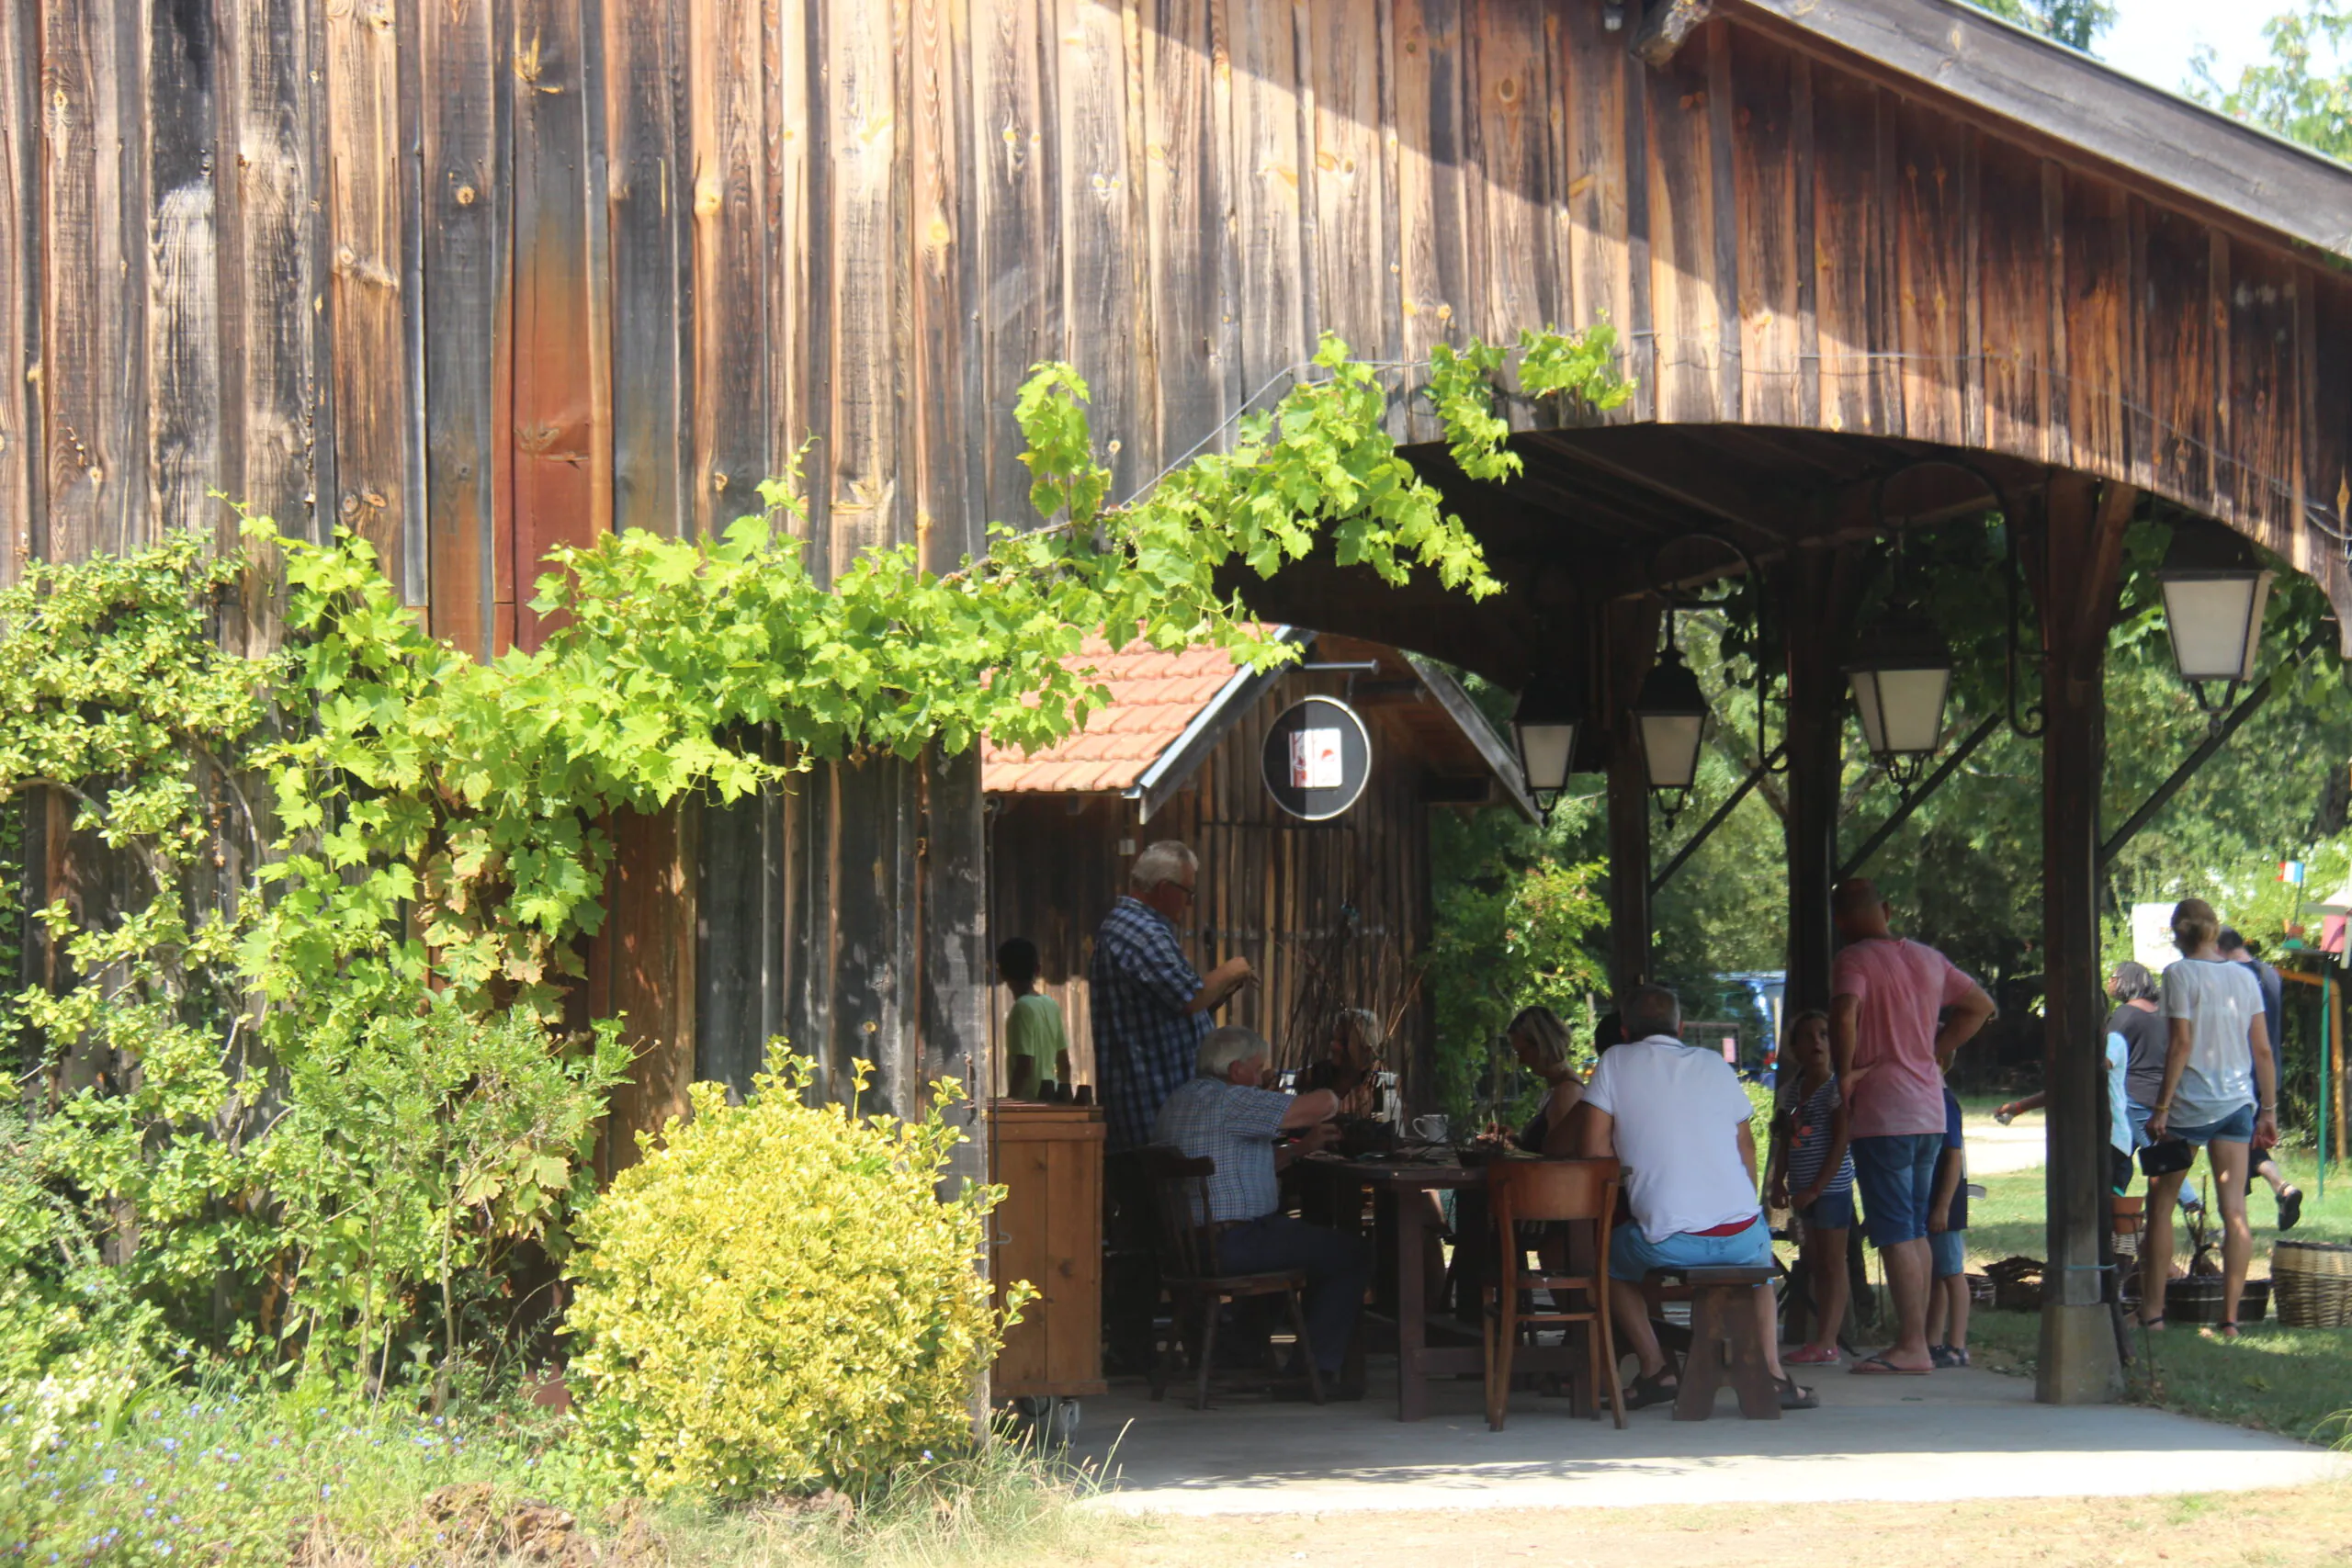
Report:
327,0,416,570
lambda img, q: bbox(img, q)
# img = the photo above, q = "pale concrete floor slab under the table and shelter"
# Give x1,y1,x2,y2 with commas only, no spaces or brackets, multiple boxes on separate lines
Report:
1072,1359,2352,1514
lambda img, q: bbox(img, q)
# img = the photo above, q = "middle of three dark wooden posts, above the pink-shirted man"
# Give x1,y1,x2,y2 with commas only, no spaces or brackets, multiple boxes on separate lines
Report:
1781,550,1849,1018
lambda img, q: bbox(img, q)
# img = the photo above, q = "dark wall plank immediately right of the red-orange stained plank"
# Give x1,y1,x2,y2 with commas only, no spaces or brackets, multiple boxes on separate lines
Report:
602,0,686,538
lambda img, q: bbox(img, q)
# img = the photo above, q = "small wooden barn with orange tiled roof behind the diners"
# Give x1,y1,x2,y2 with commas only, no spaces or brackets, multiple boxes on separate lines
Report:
981,627,1536,1098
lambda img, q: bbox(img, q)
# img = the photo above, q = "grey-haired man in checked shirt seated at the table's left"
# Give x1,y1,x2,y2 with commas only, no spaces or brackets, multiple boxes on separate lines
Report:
1152,1025,1371,1399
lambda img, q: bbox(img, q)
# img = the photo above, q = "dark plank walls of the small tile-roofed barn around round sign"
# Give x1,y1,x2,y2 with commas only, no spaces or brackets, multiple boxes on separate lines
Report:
988,670,1446,1104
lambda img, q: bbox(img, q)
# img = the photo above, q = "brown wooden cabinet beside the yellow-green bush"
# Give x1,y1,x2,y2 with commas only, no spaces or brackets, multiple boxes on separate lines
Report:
988,1100,1103,1399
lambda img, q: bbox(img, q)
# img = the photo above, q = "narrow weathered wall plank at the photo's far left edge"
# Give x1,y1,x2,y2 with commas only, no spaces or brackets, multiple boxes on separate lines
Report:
0,5,45,588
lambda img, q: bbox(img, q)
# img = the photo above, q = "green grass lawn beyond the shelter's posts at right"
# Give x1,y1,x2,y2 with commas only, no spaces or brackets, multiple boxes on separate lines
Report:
1969,1128,2352,1441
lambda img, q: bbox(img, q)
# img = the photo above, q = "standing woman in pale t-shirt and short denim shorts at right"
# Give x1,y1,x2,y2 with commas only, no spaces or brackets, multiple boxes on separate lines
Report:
2141,898,2279,1340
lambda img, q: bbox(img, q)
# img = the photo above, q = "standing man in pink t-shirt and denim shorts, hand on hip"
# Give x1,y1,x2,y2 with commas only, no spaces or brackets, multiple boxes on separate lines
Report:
1830,877,1992,1378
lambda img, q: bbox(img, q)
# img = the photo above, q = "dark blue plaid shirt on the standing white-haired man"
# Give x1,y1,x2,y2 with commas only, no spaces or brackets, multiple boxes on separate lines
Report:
1087,898,1209,1152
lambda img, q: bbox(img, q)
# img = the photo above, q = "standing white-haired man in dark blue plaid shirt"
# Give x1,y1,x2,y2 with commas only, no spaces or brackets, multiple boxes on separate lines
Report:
1087,840,1251,1371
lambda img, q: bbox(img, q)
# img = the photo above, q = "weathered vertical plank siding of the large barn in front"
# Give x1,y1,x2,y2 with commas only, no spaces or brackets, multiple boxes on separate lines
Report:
0,0,2352,1152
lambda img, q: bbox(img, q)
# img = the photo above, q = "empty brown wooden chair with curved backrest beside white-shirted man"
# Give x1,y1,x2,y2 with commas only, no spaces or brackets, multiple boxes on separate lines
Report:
1484,1159,1625,1432
